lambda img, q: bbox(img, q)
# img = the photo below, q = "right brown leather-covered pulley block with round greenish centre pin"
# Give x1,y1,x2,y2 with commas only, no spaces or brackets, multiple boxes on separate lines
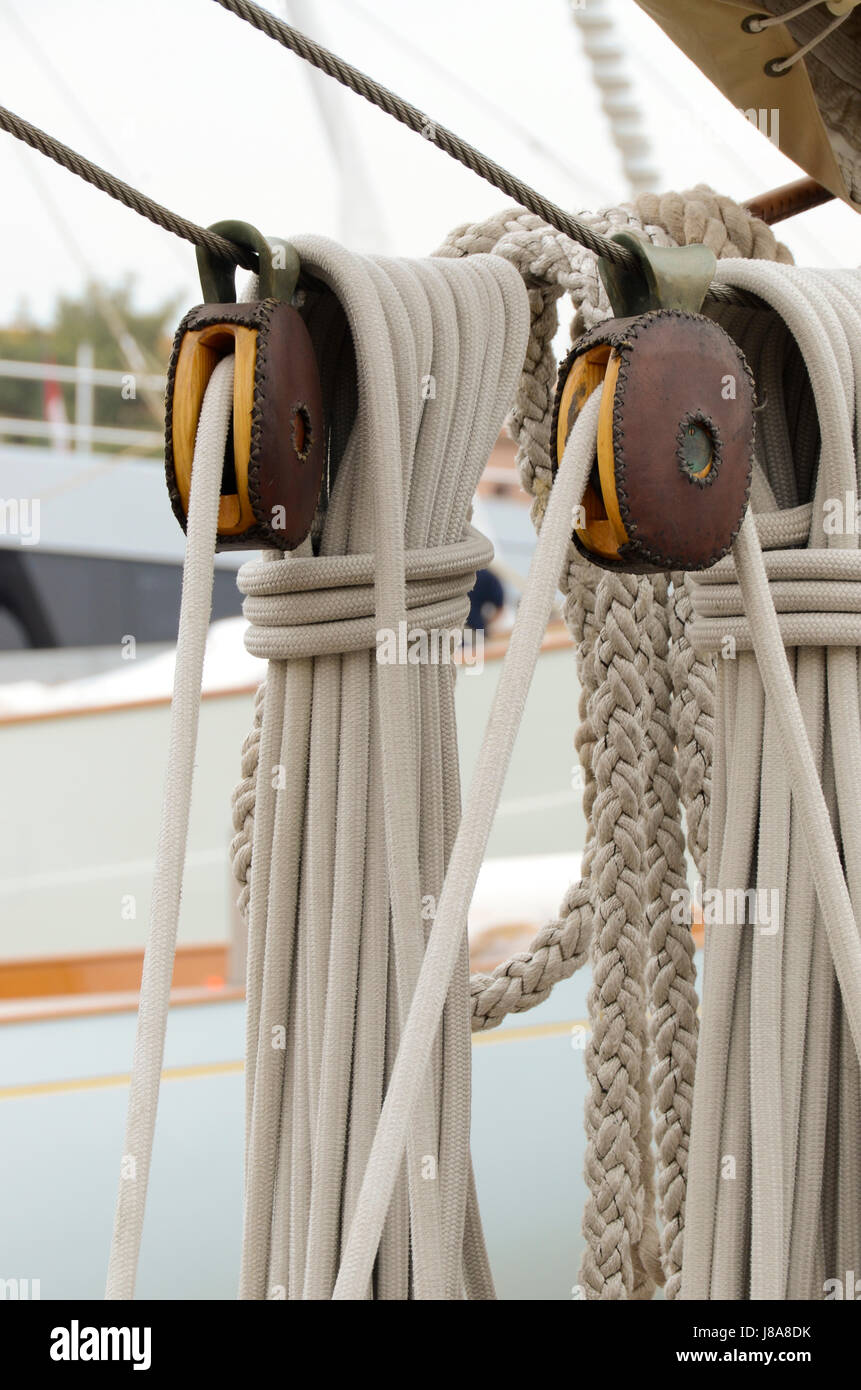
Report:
551,236,754,573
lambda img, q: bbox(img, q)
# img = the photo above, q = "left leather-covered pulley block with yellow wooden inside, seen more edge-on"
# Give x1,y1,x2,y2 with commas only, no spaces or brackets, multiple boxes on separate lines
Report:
166,222,325,550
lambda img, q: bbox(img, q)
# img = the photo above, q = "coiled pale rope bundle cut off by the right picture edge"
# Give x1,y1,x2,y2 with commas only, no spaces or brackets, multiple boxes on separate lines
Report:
682,261,861,1298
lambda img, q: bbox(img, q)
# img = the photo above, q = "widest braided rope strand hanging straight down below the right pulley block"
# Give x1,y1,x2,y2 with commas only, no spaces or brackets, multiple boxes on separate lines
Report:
580,573,654,1298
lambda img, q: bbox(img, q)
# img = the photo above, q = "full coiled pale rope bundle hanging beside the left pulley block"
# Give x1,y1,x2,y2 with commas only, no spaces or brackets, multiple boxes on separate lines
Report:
241,238,527,1298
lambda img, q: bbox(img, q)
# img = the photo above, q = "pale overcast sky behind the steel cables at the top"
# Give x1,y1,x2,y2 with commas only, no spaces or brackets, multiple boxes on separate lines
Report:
0,0,858,322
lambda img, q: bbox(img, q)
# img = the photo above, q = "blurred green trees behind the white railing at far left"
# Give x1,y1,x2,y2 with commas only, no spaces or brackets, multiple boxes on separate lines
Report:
0,277,181,453
